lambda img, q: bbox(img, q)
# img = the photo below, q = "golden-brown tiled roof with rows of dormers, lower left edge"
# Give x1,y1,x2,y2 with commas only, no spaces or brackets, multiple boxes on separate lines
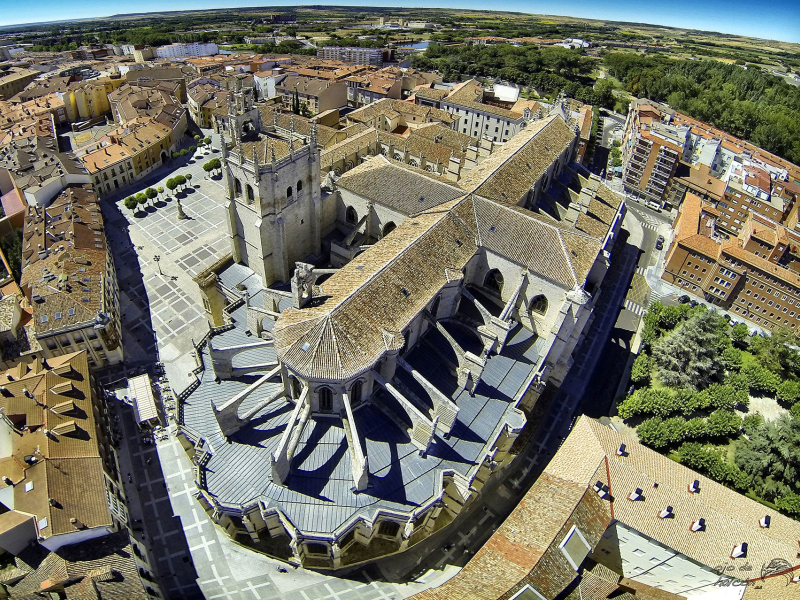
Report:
0,352,113,538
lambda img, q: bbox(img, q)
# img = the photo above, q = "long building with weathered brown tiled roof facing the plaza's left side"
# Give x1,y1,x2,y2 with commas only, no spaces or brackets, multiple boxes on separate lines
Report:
20,185,123,367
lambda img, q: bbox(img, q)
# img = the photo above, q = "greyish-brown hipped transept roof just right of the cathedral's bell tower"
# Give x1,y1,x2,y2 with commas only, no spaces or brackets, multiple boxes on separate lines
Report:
336,154,464,215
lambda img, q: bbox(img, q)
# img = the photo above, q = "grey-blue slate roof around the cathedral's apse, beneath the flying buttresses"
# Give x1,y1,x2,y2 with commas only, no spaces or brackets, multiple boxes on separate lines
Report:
183,266,544,534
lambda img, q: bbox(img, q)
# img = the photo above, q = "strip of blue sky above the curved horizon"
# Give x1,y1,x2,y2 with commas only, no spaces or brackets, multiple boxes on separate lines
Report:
0,0,800,43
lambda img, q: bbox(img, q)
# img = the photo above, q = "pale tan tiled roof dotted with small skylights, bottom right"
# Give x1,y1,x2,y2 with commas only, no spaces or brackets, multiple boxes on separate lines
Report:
560,417,800,577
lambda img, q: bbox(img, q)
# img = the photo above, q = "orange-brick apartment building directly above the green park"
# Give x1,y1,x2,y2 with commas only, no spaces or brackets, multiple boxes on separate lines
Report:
662,194,800,329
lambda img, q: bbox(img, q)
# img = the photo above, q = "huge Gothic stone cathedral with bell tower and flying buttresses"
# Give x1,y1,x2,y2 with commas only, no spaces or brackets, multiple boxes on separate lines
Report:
179,90,625,571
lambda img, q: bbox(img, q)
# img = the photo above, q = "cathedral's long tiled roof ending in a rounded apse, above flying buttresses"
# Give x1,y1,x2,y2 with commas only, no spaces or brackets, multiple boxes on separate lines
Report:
272,204,477,380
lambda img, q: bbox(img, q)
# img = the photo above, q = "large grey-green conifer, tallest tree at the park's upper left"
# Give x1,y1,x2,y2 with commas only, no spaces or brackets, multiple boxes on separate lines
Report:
653,311,729,389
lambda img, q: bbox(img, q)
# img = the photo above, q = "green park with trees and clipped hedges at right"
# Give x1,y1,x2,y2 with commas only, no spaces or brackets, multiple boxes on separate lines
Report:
617,302,800,518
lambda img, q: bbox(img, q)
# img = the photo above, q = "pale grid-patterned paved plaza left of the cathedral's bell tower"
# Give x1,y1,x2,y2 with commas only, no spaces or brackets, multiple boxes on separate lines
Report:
101,134,230,390
